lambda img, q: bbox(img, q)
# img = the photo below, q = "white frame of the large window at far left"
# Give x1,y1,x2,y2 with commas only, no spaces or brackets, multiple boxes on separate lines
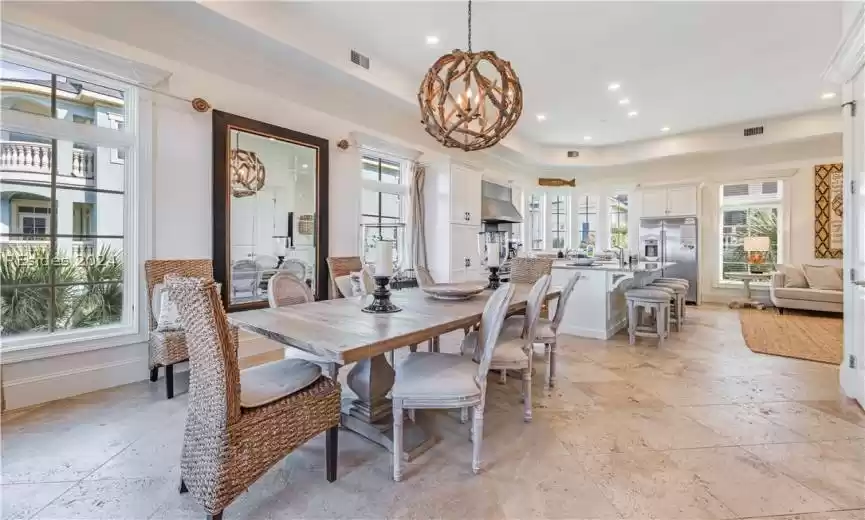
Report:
0,43,156,358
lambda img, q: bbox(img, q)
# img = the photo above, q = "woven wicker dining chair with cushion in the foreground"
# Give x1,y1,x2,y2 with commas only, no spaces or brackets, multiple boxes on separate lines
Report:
167,277,340,520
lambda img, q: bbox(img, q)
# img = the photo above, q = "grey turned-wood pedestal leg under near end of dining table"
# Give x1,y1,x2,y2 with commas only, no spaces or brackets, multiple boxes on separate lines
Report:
342,354,436,460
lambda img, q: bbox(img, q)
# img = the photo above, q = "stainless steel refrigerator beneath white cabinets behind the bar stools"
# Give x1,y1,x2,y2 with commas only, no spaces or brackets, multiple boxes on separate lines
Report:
640,217,700,303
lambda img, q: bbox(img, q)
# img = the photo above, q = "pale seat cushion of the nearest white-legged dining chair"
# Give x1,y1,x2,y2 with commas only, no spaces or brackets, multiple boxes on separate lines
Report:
390,352,481,399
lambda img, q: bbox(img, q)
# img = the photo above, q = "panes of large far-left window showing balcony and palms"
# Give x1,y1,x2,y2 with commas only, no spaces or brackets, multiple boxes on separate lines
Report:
0,52,138,347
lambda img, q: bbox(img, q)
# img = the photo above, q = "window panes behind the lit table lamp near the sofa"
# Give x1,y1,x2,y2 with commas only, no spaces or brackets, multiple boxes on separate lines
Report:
719,180,783,281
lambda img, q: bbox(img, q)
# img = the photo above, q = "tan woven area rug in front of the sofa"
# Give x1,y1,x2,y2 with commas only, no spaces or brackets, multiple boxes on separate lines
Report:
739,309,844,365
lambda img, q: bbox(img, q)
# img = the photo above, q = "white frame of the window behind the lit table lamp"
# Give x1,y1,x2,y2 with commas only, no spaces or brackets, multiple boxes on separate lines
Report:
715,178,789,287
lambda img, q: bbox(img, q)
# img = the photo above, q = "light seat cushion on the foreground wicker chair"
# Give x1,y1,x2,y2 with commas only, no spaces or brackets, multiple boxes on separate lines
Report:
240,359,321,408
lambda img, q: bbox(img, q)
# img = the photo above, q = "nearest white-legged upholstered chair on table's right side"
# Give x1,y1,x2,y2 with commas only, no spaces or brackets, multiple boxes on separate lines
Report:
390,284,516,482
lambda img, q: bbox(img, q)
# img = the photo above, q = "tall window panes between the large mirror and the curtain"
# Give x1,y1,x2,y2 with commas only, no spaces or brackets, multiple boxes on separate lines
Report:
361,156,408,268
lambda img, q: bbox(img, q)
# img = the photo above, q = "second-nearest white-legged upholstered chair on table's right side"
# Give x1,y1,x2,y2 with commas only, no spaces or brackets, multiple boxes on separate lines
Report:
460,274,551,422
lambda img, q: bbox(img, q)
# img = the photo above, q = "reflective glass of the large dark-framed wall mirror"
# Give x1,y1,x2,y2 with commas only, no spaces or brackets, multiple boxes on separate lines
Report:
228,128,318,304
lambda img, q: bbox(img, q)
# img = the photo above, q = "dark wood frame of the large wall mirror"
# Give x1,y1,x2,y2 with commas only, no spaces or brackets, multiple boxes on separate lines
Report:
213,110,329,312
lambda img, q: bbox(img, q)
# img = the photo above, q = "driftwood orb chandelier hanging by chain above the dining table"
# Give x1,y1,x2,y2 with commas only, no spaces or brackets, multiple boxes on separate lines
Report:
417,0,523,152
